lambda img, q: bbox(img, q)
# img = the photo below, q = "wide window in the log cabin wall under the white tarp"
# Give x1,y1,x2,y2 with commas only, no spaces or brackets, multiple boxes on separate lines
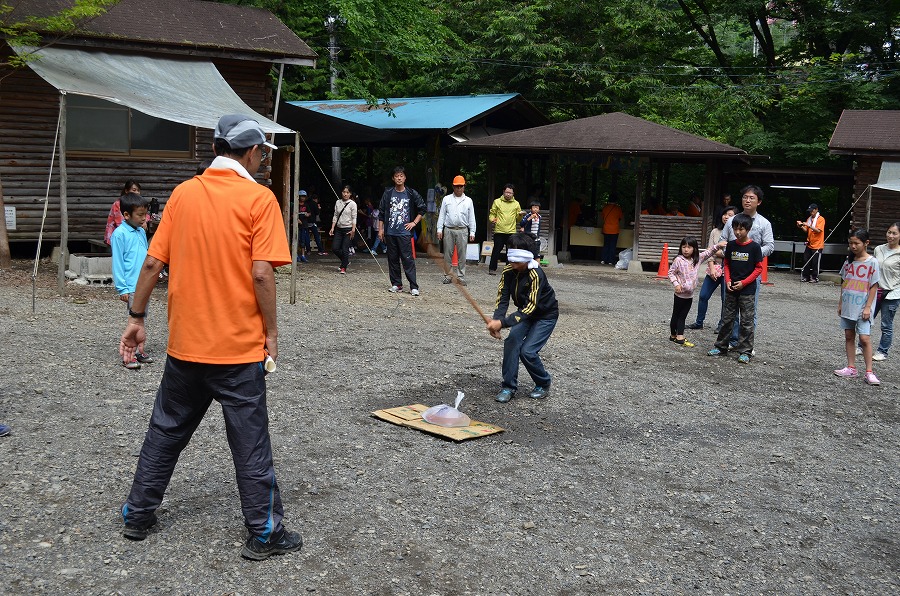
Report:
66,95,194,158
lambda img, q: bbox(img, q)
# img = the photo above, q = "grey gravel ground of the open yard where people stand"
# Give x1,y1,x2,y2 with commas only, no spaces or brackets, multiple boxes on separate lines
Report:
0,256,900,595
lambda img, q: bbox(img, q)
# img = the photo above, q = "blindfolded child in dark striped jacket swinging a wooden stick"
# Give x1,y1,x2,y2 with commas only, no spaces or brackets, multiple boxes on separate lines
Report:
487,233,559,403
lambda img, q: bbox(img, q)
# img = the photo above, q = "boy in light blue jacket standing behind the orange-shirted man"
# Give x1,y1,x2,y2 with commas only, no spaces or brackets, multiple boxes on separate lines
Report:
109,192,153,370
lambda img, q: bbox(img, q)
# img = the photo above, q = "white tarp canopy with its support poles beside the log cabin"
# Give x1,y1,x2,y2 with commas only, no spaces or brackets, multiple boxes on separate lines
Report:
14,46,300,302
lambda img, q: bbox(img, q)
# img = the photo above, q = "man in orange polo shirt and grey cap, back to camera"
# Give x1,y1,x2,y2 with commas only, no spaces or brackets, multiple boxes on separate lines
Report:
119,115,303,560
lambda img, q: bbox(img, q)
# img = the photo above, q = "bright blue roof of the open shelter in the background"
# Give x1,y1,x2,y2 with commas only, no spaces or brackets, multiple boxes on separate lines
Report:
287,93,520,131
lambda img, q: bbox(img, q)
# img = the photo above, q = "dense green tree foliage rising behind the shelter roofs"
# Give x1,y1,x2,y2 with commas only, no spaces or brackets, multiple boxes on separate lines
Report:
218,0,900,164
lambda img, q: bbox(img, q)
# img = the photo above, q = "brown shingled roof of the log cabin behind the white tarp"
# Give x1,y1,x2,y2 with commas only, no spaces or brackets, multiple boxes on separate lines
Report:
5,0,317,62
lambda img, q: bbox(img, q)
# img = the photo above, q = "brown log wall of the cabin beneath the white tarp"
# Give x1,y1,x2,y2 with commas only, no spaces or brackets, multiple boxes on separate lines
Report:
0,53,273,242
